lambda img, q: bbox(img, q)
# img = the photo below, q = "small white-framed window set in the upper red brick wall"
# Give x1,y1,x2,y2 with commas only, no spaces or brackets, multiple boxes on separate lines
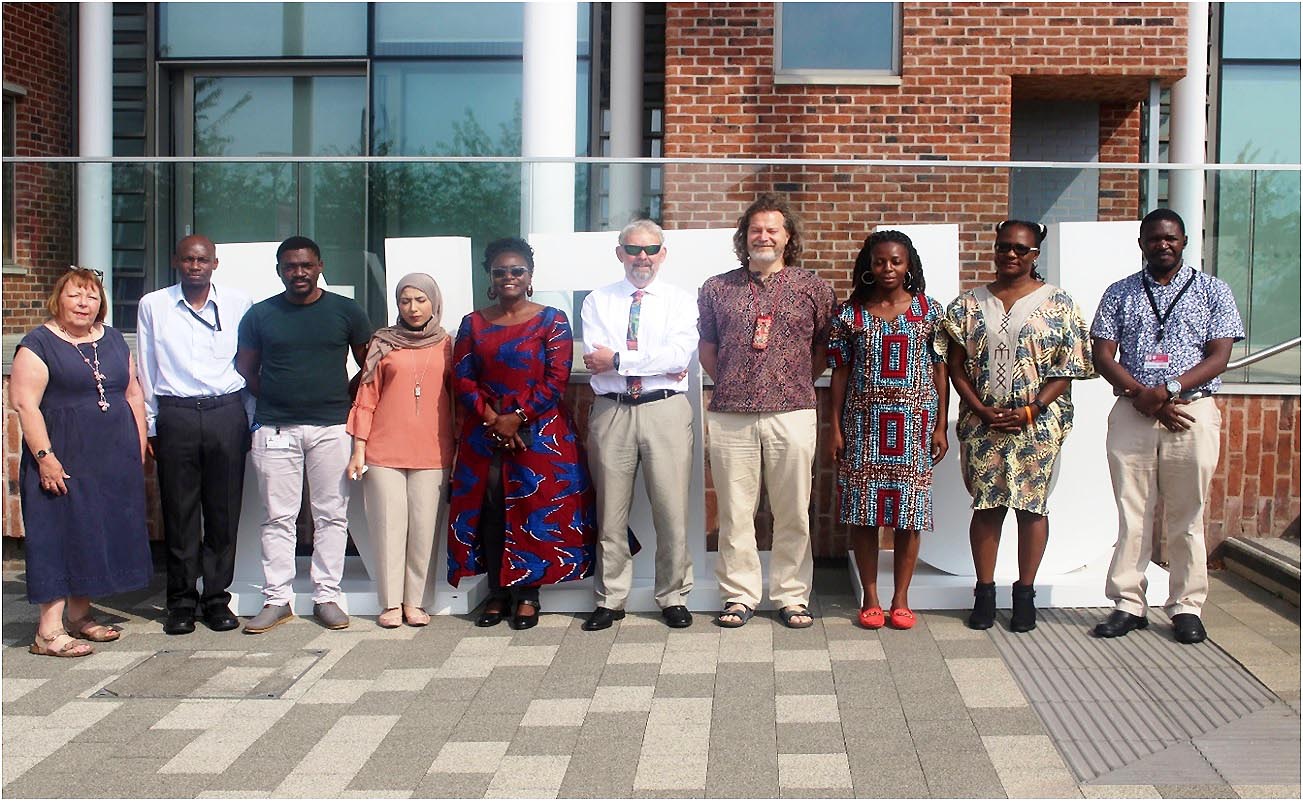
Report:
779,3,895,72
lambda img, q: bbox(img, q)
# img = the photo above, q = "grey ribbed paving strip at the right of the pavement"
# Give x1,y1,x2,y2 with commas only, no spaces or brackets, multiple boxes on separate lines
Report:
992,610,1299,784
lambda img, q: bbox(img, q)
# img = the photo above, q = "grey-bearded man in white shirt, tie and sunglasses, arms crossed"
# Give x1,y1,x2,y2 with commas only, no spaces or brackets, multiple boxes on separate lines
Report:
581,220,697,632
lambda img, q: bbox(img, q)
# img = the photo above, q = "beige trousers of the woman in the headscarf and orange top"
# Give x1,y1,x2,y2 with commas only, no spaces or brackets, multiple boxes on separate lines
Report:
362,465,448,610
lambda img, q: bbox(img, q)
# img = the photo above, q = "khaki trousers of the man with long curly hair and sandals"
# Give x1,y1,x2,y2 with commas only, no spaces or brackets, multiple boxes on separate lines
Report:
706,409,818,608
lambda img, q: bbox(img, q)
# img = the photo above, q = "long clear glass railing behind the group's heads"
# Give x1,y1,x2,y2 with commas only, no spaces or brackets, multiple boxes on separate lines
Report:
4,158,1300,386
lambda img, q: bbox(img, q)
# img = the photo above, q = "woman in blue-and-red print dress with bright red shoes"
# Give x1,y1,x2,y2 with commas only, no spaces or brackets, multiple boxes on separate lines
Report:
827,231,949,629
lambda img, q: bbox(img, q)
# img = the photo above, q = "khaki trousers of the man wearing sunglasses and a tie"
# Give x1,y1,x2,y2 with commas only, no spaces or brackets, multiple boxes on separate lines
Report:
588,393,693,610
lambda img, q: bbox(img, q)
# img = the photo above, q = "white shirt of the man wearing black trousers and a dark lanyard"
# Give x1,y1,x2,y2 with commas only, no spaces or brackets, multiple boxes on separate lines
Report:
136,284,253,436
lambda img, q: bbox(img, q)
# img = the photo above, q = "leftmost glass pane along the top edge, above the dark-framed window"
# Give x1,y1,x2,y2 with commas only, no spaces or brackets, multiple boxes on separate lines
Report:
159,3,366,59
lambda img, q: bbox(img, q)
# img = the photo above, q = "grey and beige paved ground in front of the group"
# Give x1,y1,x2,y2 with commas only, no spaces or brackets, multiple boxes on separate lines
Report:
0,569,1299,798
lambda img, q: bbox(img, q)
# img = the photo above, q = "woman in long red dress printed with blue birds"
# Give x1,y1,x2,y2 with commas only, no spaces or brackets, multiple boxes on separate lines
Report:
448,238,597,629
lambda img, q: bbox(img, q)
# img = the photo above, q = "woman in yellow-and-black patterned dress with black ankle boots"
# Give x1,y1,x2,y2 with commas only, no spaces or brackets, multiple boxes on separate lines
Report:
943,220,1095,632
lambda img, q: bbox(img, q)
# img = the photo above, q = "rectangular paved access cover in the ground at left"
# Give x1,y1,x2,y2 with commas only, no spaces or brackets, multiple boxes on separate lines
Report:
91,650,326,698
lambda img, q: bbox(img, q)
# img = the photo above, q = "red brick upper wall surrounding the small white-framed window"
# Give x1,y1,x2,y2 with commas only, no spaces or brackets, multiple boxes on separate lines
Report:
663,3,1187,293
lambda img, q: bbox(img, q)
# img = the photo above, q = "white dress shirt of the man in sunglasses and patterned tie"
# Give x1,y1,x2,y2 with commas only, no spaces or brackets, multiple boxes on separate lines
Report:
580,279,697,395
